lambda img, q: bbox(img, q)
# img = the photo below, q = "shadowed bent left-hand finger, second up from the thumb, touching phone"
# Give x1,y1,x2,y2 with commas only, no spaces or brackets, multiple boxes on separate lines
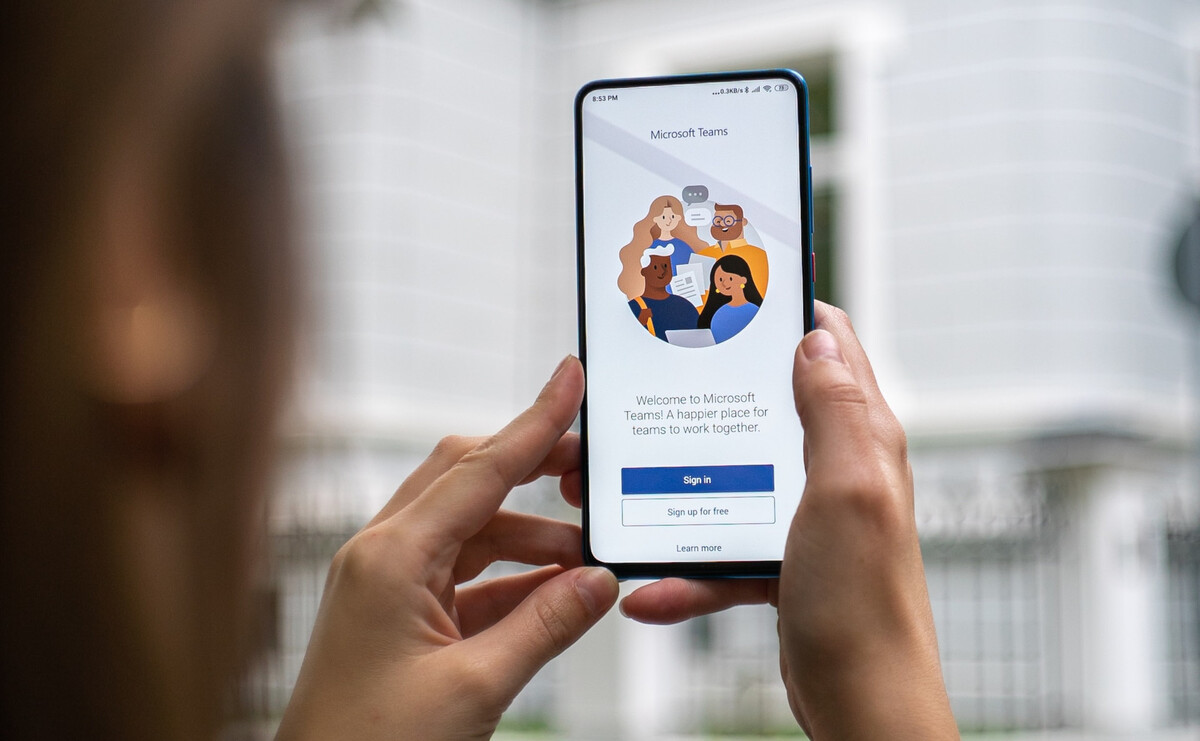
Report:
454,510,583,584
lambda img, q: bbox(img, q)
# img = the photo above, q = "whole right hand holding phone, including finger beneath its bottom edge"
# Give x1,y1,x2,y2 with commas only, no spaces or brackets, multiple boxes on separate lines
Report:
614,303,959,740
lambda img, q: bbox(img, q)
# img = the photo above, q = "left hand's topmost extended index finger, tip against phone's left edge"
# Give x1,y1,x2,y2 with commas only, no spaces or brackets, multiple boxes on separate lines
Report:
404,357,583,546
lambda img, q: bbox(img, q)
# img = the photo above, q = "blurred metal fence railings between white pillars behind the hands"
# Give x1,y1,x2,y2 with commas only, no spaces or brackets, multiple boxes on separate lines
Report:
236,460,1200,734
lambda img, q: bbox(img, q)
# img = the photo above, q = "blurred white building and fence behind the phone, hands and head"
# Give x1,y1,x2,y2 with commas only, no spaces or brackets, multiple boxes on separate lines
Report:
240,0,1200,740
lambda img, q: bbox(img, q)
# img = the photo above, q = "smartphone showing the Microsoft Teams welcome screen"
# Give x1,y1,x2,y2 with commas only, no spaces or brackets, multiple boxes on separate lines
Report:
575,70,815,578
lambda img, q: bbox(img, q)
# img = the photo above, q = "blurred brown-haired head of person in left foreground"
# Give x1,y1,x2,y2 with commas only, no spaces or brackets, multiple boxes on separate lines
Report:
0,0,293,739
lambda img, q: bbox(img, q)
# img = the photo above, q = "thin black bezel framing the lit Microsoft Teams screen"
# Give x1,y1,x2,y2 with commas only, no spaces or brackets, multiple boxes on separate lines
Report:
575,68,815,579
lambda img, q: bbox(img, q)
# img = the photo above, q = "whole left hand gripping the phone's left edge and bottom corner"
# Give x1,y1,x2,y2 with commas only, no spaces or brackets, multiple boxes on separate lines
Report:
277,359,617,741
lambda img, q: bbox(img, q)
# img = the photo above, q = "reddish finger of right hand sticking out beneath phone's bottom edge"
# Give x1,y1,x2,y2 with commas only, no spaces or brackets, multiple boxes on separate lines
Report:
620,579,779,625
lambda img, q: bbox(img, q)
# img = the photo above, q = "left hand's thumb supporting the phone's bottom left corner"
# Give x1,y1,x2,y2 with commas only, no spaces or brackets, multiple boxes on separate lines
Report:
458,567,618,698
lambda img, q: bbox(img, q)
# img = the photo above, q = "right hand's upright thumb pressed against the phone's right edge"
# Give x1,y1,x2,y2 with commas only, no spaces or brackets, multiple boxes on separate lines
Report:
792,330,872,476
